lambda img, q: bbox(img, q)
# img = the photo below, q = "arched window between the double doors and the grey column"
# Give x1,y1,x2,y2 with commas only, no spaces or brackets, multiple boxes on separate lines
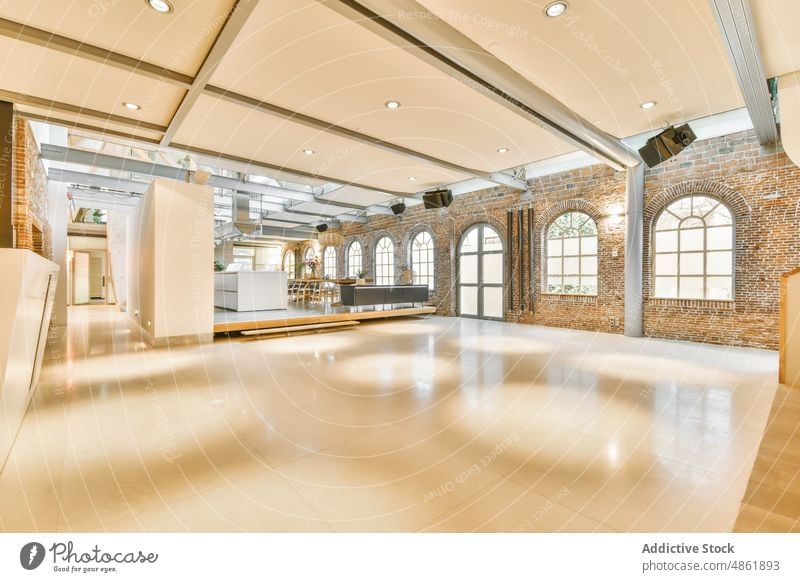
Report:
545,211,597,295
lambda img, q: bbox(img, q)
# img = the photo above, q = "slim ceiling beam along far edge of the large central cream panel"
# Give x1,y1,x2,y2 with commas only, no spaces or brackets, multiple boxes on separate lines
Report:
205,85,526,192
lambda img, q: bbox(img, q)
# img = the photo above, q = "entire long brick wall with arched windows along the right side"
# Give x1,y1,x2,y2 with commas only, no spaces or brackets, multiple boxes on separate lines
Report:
337,132,800,348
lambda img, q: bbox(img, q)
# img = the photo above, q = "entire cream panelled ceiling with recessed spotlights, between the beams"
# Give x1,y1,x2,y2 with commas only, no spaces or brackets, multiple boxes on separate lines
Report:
0,0,788,216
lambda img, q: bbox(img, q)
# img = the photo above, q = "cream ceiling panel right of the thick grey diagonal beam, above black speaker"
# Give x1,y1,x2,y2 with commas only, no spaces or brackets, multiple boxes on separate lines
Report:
420,0,742,138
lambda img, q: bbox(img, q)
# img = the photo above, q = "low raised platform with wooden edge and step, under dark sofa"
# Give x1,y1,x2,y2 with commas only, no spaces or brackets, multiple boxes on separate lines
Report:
214,303,436,333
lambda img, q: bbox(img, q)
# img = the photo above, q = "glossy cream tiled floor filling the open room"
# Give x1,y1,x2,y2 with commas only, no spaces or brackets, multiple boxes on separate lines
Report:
0,307,788,532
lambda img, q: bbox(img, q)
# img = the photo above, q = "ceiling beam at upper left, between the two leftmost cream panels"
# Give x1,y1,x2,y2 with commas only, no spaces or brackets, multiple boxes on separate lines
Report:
0,18,192,89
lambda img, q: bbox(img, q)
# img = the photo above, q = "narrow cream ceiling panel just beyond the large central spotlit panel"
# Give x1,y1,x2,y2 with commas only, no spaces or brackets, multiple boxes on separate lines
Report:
175,95,465,192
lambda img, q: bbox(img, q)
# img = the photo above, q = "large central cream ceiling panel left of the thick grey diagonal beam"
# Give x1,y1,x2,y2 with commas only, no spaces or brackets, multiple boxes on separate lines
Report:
211,0,574,171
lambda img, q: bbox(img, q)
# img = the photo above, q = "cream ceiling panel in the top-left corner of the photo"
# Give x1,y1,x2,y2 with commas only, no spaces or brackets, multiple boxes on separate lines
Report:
0,0,234,75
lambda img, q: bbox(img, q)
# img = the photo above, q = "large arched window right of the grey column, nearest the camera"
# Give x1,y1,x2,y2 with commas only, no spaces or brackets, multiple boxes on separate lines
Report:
653,195,733,300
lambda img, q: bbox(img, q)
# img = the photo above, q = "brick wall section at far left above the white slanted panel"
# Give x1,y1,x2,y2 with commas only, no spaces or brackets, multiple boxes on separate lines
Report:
12,118,53,259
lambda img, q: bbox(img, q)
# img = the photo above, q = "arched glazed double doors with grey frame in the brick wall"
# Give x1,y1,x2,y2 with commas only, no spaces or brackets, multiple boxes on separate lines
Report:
458,224,505,321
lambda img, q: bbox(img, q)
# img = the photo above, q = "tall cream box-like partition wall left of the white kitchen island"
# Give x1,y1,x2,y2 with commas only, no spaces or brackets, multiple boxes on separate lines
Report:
127,179,214,346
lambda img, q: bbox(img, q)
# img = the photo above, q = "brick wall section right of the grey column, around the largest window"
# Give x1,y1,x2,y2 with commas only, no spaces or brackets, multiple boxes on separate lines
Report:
644,132,800,348
